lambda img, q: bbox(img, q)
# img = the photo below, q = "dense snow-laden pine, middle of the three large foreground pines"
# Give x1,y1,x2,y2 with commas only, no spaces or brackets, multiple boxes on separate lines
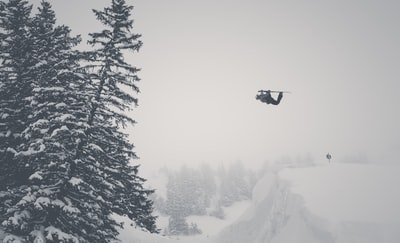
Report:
2,1,94,242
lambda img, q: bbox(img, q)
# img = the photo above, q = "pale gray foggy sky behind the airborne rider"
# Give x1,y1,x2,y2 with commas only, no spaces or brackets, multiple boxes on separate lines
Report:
31,0,400,170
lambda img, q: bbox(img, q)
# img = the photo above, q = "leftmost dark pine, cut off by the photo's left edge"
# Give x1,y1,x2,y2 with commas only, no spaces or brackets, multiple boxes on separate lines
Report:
0,0,32,192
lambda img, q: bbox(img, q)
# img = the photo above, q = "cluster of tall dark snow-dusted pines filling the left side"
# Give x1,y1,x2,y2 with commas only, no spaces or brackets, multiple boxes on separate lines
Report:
0,0,157,242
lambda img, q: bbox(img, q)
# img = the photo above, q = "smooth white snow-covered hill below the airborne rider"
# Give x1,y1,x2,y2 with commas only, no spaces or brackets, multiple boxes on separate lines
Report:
117,163,400,243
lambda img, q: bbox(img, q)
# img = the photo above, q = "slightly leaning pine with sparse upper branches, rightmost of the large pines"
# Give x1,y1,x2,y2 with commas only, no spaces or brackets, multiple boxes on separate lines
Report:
83,0,157,236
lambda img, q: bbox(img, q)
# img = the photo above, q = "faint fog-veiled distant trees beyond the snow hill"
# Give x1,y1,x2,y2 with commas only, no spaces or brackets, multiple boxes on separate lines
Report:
154,162,257,235
